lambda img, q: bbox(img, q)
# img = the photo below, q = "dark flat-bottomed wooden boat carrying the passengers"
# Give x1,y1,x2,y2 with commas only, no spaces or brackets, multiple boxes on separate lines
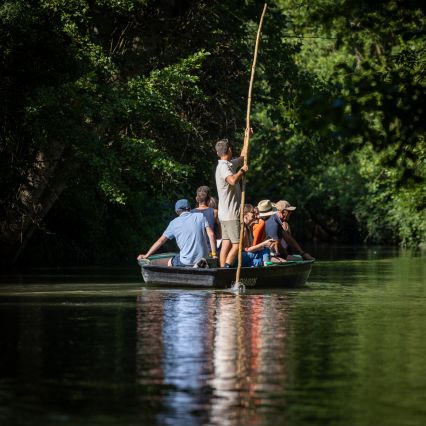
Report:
139,253,314,289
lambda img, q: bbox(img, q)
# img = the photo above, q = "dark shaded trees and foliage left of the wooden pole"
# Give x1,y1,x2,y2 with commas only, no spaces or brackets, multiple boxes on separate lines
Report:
0,0,272,261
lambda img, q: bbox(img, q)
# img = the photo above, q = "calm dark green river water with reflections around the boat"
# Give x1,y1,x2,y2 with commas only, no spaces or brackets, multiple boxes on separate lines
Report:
0,248,426,426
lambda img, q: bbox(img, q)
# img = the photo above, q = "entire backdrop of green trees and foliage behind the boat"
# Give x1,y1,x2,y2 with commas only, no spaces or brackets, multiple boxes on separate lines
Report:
0,0,426,263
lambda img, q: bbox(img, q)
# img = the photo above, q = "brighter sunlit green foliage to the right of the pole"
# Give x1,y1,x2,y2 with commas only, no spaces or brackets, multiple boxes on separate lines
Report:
252,0,426,245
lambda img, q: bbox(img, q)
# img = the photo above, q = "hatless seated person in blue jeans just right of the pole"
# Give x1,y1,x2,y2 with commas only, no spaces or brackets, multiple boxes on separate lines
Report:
242,204,274,266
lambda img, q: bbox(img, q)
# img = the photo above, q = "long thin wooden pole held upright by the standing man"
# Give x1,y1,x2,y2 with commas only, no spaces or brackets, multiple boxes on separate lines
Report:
235,3,267,284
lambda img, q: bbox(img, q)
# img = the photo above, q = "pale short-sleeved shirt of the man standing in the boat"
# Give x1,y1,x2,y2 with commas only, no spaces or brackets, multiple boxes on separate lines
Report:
216,158,241,222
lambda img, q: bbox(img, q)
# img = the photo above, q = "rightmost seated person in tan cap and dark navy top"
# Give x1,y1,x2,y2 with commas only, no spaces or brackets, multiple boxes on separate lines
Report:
265,200,314,262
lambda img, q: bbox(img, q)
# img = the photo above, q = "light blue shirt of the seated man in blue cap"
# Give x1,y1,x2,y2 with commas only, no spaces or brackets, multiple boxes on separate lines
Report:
163,212,209,265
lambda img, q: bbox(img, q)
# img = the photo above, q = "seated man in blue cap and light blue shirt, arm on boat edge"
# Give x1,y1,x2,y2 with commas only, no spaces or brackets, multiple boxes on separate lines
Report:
137,199,215,267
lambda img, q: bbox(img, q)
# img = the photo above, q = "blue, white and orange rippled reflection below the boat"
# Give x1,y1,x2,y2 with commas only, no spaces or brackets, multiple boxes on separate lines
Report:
136,291,288,425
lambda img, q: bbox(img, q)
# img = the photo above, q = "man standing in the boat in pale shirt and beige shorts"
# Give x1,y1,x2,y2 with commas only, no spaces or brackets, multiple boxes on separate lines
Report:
216,139,248,268
